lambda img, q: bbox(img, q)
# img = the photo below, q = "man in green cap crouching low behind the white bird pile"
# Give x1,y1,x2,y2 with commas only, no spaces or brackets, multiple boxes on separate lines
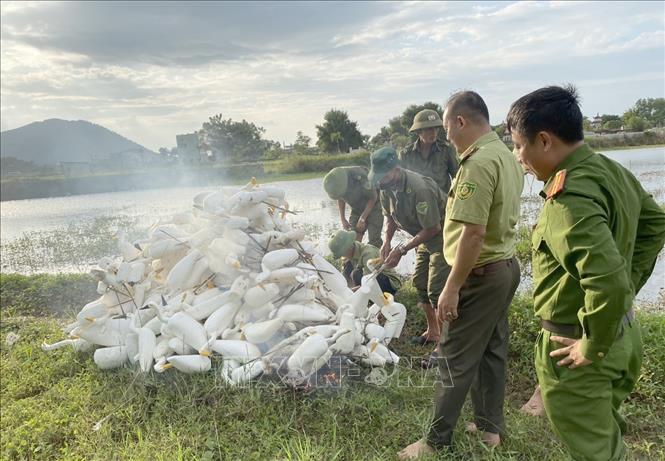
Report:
328,230,402,295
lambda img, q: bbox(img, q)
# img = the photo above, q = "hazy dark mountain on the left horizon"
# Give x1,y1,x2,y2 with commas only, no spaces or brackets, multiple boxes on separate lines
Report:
0,118,152,165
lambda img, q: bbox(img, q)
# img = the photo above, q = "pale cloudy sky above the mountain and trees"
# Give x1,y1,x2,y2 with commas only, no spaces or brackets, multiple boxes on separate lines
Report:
0,1,665,149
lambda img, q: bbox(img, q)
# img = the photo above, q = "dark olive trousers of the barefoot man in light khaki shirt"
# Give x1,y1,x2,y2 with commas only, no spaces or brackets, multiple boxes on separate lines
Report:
427,258,520,447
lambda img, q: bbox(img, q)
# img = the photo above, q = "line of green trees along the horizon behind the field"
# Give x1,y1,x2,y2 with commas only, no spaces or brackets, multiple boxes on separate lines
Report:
159,98,665,163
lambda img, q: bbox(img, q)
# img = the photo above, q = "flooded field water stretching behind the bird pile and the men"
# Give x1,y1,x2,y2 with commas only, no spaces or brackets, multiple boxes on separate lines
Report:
0,147,665,308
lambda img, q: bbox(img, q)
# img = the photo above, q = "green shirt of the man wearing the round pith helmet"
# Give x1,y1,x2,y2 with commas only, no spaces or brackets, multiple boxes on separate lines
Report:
398,140,459,194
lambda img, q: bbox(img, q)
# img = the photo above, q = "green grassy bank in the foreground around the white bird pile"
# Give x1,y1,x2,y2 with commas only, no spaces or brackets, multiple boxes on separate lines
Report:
0,274,665,461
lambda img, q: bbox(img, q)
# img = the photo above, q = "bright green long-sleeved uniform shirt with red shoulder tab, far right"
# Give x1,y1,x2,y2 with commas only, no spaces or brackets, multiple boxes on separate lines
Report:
532,145,665,360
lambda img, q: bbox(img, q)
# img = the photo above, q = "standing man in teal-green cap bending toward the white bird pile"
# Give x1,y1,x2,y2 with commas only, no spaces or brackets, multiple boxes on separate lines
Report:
369,147,449,340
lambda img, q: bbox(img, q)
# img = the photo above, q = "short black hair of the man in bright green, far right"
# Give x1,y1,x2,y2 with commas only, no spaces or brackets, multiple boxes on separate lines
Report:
506,84,584,144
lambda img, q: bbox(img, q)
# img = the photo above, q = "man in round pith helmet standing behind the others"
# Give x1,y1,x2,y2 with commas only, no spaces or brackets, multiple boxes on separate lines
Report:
399,109,459,194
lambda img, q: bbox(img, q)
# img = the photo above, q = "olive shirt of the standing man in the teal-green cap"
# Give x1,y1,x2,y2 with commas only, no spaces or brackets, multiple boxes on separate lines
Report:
380,169,445,239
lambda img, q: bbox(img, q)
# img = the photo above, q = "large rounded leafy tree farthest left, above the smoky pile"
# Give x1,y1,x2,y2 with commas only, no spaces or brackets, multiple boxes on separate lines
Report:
199,114,268,162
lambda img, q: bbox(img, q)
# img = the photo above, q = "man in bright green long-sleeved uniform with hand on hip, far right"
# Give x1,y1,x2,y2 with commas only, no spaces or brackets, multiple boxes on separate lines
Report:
507,87,665,461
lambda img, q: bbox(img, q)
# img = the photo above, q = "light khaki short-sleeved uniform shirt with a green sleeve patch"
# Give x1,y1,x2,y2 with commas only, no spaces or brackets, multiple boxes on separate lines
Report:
443,131,524,267
